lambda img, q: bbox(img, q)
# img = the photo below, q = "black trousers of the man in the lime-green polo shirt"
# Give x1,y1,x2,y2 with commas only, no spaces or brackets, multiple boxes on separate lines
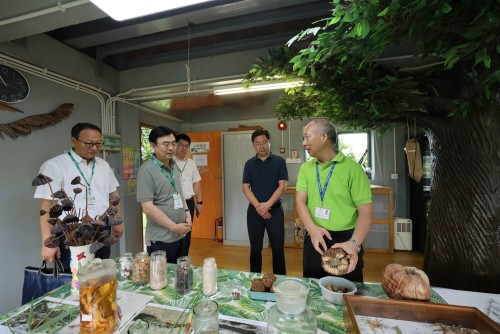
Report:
302,230,365,282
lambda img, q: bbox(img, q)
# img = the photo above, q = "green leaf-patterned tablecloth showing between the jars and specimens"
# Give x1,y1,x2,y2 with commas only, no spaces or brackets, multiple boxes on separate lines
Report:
0,264,446,333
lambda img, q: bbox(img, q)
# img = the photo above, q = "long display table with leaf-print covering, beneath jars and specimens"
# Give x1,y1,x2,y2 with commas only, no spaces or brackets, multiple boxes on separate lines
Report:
0,264,500,334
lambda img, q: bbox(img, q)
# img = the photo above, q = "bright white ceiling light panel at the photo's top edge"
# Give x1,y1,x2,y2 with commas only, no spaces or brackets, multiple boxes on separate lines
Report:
90,0,213,21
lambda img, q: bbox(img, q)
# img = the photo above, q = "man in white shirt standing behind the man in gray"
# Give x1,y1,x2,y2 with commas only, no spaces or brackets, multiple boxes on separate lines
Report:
174,133,203,256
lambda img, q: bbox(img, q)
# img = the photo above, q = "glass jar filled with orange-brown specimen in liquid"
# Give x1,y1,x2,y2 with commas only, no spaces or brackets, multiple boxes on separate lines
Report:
78,259,120,333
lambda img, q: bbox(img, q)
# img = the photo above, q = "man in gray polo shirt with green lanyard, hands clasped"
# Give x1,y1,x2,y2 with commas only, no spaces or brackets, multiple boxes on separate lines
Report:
137,126,192,263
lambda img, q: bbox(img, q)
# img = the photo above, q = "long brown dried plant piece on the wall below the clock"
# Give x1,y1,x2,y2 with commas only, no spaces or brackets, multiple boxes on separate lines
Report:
0,103,73,139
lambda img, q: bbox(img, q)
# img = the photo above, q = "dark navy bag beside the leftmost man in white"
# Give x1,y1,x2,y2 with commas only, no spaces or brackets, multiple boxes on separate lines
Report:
22,259,72,304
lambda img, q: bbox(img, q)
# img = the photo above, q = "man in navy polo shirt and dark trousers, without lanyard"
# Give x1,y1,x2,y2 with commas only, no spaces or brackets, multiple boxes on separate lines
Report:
243,129,288,275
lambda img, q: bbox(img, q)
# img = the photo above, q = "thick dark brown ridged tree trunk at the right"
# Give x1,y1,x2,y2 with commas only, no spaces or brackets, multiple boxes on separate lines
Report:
424,110,500,293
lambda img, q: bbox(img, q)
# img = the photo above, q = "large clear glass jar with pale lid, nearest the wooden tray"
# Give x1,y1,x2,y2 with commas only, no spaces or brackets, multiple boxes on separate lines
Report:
267,278,317,334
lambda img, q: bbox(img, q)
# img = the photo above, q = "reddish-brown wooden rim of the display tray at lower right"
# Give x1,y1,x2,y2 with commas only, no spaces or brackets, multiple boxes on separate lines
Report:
343,295,500,334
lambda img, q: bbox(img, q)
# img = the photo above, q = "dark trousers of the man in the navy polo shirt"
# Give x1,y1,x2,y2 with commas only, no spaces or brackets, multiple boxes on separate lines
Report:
247,204,286,275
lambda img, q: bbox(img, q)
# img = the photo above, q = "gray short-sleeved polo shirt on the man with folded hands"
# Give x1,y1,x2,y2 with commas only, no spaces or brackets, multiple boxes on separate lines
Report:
137,157,186,246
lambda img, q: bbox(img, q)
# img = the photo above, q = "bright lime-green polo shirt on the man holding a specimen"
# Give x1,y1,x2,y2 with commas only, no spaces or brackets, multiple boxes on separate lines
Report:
295,152,372,231
